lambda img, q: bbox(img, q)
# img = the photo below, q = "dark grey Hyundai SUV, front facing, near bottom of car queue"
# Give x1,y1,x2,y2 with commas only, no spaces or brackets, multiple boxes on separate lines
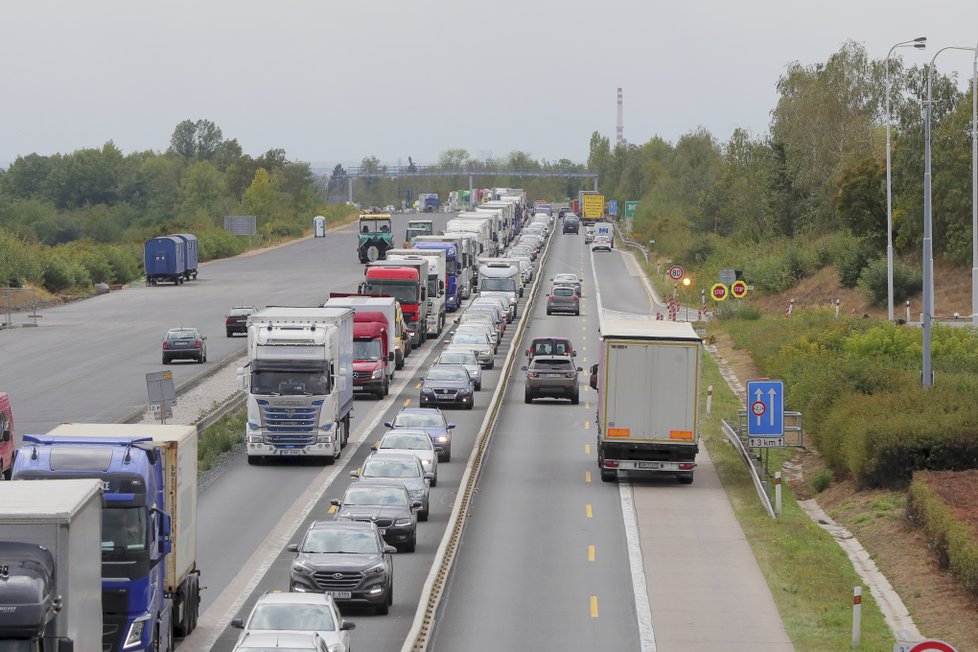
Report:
286,516,396,614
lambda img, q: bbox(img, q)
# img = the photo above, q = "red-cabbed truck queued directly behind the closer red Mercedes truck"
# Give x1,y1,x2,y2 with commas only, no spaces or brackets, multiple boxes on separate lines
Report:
358,259,428,346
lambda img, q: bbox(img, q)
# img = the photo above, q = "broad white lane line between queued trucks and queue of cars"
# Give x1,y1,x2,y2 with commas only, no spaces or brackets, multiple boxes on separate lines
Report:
180,338,434,652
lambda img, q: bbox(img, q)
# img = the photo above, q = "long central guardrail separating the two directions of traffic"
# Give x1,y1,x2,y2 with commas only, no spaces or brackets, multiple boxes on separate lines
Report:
401,222,557,652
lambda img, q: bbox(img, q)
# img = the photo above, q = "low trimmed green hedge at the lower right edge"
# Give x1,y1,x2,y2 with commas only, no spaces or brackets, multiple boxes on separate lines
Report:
907,473,978,595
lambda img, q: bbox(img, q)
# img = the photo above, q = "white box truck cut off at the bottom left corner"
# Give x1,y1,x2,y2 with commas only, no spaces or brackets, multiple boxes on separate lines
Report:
0,479,102,652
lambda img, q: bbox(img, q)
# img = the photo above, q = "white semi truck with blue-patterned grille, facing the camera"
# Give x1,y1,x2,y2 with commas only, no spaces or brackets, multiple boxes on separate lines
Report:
237,307,354,464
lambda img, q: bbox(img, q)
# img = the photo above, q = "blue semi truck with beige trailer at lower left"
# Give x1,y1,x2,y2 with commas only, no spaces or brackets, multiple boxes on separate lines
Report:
13,423,200,652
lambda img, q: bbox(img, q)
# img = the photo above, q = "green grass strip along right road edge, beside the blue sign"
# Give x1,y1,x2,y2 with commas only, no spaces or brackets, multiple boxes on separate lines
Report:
702,346,893,652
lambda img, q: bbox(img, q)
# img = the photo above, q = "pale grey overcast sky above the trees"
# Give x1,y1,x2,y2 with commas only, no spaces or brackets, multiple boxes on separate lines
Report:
0,0,978,164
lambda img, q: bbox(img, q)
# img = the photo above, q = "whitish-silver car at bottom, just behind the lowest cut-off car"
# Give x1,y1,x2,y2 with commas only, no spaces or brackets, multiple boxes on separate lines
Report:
231,591,357,652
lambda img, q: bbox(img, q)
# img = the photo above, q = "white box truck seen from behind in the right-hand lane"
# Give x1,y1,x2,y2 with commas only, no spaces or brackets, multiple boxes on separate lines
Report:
590,310,703,484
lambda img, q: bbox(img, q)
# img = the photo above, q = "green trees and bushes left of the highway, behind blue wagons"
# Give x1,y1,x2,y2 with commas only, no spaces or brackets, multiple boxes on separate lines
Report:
0,120,349,292
